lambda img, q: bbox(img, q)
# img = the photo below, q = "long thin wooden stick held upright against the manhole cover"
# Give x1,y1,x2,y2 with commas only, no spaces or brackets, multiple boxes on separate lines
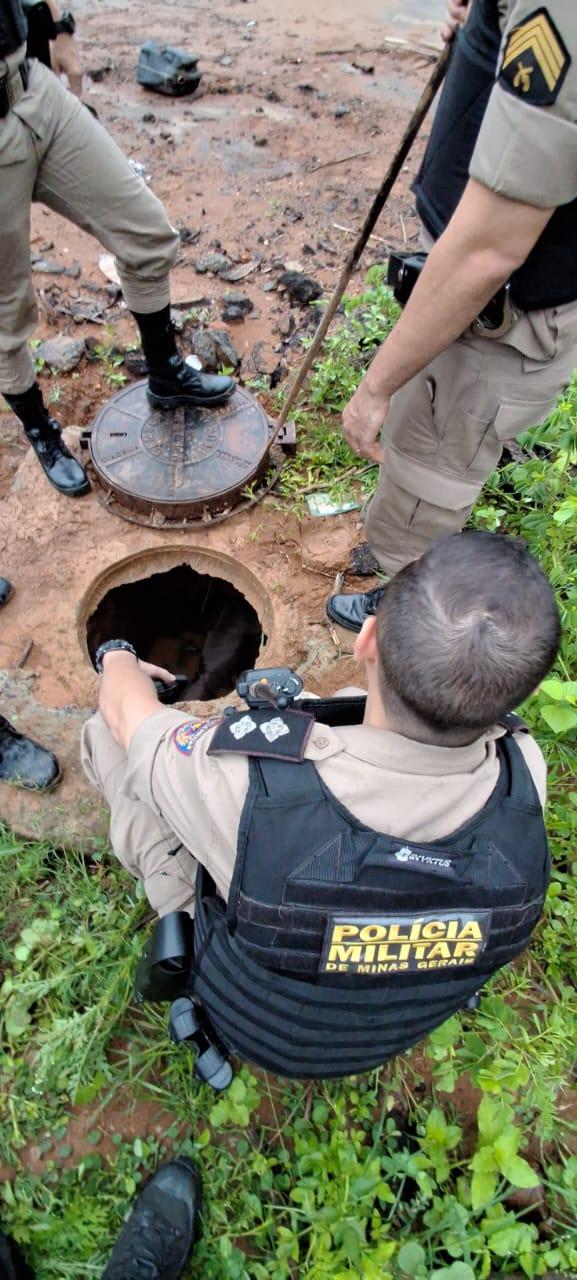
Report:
269,41,450,448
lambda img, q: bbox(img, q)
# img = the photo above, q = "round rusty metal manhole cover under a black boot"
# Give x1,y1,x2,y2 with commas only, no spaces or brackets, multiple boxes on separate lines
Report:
90,381,270,525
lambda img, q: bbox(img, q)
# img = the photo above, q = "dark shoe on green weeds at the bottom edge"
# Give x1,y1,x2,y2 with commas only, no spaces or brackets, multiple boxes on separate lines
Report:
102,1156,201,1280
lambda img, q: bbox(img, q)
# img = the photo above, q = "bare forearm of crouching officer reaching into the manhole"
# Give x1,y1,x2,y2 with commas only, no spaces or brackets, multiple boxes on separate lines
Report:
99,650,160,751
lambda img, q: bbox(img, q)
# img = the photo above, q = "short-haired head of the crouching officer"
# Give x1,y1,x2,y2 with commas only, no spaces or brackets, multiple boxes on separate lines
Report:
377,530,560,731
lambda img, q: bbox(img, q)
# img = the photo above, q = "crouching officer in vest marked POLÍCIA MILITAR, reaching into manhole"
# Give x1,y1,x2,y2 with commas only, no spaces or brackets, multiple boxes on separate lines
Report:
82,531,560,1078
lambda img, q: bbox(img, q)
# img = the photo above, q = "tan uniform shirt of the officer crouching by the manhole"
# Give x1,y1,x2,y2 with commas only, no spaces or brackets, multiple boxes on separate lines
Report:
122,709,546,909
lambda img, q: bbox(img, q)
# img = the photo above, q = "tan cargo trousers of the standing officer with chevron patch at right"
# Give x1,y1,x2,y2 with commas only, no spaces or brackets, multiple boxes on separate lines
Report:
365,302,577,573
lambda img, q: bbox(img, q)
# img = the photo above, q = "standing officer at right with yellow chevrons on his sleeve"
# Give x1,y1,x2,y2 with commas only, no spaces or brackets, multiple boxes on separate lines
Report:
328,0,577,631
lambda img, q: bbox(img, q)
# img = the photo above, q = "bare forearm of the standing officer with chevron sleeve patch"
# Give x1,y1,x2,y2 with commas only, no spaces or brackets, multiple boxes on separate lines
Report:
367,182,553,397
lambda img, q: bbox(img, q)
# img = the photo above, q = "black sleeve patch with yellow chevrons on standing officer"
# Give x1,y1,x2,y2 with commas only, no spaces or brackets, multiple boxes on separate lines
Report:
499,9,571,106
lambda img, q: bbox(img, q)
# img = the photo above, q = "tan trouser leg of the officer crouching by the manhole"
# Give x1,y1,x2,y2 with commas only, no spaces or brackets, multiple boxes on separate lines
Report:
82,712,197,915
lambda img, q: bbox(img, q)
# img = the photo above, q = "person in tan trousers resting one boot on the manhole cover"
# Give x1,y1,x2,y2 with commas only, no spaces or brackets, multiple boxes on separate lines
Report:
0,0,235,497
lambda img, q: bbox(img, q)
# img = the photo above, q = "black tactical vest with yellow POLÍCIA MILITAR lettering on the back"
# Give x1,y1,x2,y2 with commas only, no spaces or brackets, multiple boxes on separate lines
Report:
193,710,549,1078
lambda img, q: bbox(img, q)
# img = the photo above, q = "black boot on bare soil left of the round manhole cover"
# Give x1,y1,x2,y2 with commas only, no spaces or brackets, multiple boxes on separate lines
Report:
3,383,90,498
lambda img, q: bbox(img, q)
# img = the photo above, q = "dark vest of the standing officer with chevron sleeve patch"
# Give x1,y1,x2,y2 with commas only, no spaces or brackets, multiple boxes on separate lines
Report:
413,0,577,311
